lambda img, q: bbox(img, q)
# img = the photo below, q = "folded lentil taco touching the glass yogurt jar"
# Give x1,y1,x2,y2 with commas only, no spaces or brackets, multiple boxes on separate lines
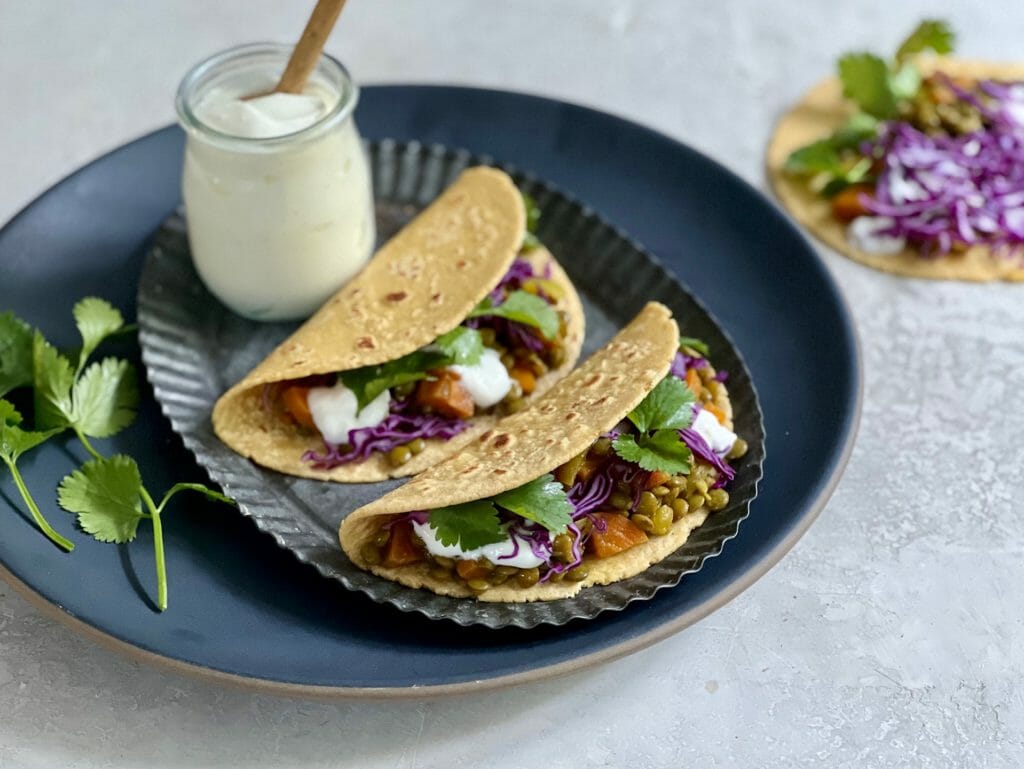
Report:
213,167,584,482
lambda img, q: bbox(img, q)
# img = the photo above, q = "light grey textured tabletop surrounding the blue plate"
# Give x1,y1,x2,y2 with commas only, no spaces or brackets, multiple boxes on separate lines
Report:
0,0,1024,769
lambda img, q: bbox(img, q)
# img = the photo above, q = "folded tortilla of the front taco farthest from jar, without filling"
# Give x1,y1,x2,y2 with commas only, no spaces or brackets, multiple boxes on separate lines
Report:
339,302,732,603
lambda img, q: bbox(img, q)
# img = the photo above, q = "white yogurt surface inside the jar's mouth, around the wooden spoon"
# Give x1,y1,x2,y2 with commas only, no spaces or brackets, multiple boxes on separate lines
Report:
196,89,328,139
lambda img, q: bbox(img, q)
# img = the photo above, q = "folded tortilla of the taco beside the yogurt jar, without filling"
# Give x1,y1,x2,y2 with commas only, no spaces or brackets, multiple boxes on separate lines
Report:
213,168,585,483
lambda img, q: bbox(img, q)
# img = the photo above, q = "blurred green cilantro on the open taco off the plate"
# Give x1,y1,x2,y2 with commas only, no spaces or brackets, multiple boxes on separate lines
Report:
783,19,954,196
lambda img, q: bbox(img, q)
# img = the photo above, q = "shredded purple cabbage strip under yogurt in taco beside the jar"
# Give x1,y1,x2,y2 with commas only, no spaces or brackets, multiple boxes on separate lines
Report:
302,399,467,470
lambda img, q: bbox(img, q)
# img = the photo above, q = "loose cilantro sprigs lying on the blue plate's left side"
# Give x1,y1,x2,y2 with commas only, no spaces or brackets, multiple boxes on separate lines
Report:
0,297,233,610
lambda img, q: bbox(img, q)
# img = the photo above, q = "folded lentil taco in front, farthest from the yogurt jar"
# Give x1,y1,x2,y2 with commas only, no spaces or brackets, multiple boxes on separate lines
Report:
339,303,746,602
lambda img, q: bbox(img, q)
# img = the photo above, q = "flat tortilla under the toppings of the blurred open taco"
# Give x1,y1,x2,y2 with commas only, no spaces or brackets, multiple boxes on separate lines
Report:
767,58,1024,283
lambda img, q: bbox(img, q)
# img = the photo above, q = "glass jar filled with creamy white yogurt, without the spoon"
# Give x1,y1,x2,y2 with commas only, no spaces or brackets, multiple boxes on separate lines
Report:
176,43,376,321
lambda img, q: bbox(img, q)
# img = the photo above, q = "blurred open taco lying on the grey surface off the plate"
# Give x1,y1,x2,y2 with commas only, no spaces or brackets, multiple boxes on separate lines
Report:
767,22,1024,282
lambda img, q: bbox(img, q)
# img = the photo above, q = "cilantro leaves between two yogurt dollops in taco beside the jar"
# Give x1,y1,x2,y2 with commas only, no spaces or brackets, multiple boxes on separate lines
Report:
339,326,483,411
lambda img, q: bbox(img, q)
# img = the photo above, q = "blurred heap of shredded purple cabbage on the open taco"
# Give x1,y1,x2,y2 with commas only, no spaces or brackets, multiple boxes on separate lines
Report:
862,79,1024,255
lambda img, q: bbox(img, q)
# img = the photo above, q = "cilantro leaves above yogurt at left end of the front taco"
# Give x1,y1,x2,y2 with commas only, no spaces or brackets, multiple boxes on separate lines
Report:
429,473,572,551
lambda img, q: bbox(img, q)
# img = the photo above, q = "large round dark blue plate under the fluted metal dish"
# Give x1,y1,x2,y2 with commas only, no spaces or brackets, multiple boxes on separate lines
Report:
0,86,860,696
